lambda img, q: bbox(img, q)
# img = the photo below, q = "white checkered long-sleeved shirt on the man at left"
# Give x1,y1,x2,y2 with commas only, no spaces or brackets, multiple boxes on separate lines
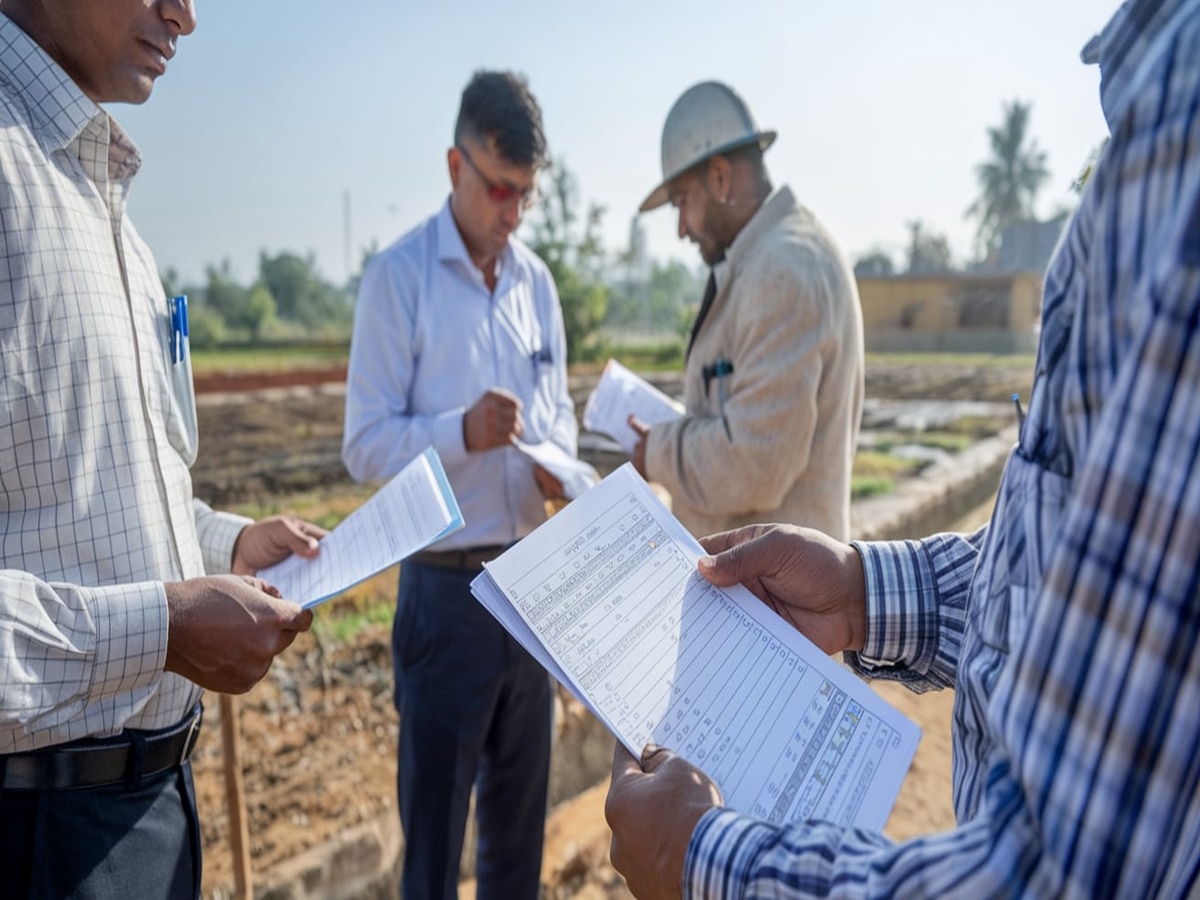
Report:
0,14,246,754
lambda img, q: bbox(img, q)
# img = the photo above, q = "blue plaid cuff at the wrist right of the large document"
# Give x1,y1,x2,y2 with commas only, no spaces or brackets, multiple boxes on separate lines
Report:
845,541,937,680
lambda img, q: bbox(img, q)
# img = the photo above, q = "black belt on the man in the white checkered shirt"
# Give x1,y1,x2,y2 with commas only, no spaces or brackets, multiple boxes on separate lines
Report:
0,706,202,791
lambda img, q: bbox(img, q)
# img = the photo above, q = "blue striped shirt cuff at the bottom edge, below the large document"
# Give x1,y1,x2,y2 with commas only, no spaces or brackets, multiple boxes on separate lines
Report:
683,809,775,900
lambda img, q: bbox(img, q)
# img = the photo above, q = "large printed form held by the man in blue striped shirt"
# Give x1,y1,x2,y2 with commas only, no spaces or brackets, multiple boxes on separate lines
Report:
470,463,920,829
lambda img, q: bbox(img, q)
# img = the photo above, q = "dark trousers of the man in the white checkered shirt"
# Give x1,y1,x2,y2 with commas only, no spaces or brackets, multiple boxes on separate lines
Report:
0,763,200,900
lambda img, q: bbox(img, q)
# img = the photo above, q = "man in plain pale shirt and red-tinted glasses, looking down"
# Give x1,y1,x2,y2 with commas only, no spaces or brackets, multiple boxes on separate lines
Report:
342,72,576,900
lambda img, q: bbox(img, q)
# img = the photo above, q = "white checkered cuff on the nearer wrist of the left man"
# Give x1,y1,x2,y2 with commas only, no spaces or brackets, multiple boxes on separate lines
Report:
87,582,170,702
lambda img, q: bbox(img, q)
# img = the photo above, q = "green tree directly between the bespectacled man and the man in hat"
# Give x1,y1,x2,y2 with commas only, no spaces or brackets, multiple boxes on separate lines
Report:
529,164,608,360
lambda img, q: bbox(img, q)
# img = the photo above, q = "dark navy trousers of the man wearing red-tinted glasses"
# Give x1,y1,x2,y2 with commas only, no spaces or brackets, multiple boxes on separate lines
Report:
392,560,551,900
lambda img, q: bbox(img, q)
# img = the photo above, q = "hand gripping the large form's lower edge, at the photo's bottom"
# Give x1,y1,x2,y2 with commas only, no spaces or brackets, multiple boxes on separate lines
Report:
604,743,725,900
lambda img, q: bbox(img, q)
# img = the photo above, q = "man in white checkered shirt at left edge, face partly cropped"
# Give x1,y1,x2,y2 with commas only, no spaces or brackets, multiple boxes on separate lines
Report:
0,0,323,898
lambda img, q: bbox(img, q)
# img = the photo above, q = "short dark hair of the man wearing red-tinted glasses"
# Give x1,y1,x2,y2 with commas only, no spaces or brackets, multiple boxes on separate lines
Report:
454,71,547,169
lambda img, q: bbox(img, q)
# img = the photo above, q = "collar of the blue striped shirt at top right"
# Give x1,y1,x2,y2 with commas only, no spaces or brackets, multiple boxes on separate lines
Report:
1080,0,1200,132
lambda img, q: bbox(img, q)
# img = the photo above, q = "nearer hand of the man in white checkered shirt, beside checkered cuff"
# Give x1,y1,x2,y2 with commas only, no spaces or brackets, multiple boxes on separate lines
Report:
164,575,312,694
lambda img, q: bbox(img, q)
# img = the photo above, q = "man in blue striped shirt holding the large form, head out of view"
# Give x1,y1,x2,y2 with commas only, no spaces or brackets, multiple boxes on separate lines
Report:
606,0,1200,898
